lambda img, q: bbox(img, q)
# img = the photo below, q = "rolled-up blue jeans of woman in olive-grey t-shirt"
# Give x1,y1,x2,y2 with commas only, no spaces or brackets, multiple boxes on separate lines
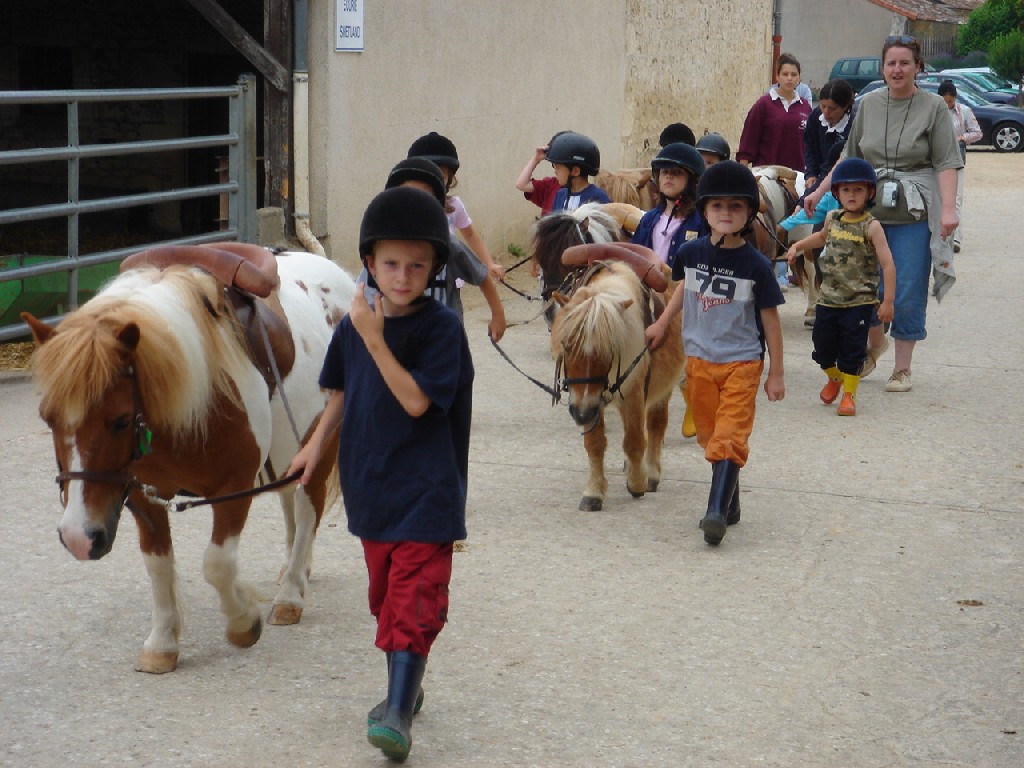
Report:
880,221,932,341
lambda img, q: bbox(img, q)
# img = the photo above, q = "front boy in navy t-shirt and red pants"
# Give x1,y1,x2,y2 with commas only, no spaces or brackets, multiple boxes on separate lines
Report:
289,186,473,760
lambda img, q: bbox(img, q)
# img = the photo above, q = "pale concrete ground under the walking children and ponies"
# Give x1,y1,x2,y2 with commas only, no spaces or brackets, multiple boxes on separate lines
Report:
0,152,1024,768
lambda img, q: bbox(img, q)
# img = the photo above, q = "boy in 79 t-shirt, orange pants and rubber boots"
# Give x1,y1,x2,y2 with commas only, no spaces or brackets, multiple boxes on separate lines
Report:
646,160,785,546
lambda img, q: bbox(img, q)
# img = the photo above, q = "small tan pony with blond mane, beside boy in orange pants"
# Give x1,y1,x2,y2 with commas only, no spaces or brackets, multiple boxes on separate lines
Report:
551,246,685,511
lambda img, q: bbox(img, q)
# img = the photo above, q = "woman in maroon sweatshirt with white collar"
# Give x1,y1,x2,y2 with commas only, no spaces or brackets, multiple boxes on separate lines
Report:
736,53,811,171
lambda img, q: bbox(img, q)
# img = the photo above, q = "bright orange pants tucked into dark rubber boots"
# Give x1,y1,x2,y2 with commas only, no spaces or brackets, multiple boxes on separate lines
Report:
686,357,764,467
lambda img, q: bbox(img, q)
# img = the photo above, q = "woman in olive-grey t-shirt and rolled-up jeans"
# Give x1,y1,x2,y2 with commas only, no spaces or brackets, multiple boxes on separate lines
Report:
804,35,963,392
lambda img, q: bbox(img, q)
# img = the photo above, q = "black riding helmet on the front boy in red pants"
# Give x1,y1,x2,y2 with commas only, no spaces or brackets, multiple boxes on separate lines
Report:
359,186,451,274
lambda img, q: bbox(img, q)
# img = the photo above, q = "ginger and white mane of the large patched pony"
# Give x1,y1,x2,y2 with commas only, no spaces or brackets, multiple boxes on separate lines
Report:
32,267,251,437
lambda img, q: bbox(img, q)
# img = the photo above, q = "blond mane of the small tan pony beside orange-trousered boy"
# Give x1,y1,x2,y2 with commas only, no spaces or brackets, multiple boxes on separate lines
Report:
551,263,643,362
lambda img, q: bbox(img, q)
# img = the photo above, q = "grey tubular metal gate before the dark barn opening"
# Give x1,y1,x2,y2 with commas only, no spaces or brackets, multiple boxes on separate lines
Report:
0,75,256,342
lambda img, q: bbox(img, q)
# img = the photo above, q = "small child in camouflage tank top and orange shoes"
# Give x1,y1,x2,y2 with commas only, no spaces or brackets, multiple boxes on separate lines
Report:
786,158,896,416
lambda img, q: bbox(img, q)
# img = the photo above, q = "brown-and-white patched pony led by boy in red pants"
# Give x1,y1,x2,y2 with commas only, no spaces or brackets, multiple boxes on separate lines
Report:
25,244,355,673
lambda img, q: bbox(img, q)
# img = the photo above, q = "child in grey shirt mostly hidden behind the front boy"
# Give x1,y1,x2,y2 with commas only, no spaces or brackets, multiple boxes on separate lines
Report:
356,158,508,341
